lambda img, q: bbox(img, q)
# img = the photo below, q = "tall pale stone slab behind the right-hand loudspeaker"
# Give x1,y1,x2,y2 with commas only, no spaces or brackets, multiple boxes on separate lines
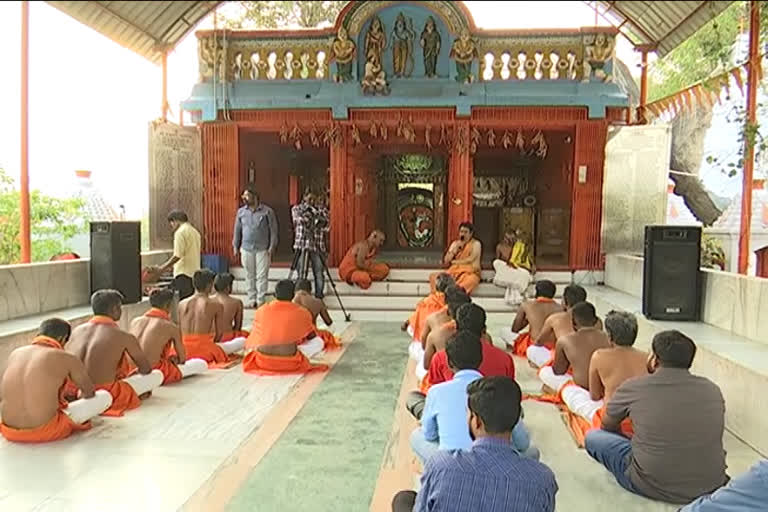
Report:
603,125,671,254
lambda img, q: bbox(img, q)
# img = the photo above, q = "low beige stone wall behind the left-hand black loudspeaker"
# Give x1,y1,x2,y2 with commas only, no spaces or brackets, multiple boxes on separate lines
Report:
0,251,170,322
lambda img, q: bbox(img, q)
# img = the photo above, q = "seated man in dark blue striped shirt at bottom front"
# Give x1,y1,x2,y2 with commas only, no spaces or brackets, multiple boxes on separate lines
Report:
392,376,557,512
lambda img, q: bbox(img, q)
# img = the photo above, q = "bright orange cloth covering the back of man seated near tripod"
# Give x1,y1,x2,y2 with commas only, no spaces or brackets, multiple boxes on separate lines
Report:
248,300,315,350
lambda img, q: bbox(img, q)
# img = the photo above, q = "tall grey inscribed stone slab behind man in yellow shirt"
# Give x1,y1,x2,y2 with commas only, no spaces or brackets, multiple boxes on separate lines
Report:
149,122,203,250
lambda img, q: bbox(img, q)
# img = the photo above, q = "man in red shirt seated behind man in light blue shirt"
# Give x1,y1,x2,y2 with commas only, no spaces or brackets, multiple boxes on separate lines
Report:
406,303,515,420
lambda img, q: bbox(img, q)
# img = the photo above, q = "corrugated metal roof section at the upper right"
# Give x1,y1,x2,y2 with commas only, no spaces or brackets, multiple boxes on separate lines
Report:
598,1,733,57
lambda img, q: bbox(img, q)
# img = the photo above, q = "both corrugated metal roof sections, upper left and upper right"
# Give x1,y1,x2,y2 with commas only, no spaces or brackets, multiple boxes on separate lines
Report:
48,1,732,63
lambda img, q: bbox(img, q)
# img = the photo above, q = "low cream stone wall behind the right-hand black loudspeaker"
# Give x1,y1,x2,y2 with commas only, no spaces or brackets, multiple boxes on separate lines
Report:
605,254,768,342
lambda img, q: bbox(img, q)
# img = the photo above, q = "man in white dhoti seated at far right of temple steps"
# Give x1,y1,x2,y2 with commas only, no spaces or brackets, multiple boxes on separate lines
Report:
493,229,533,306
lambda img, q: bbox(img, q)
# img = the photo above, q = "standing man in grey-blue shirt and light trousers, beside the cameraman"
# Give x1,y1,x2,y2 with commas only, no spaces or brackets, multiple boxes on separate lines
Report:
232,185,277,308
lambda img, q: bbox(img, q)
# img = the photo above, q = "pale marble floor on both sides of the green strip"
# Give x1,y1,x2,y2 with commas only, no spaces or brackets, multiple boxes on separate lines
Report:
0,313,759,512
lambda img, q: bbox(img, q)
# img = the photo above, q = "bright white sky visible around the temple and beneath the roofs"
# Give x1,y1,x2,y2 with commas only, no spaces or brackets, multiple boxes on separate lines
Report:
0,1,639,219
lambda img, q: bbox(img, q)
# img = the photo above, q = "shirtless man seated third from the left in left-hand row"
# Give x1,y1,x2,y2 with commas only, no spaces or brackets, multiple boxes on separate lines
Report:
131,288,208,384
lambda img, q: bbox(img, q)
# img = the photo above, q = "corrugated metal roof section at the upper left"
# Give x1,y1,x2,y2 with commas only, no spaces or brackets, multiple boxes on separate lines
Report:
48,1,222,64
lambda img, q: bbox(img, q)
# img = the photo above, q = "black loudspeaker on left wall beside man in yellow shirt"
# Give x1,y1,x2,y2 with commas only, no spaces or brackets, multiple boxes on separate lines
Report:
91,222,141,304
